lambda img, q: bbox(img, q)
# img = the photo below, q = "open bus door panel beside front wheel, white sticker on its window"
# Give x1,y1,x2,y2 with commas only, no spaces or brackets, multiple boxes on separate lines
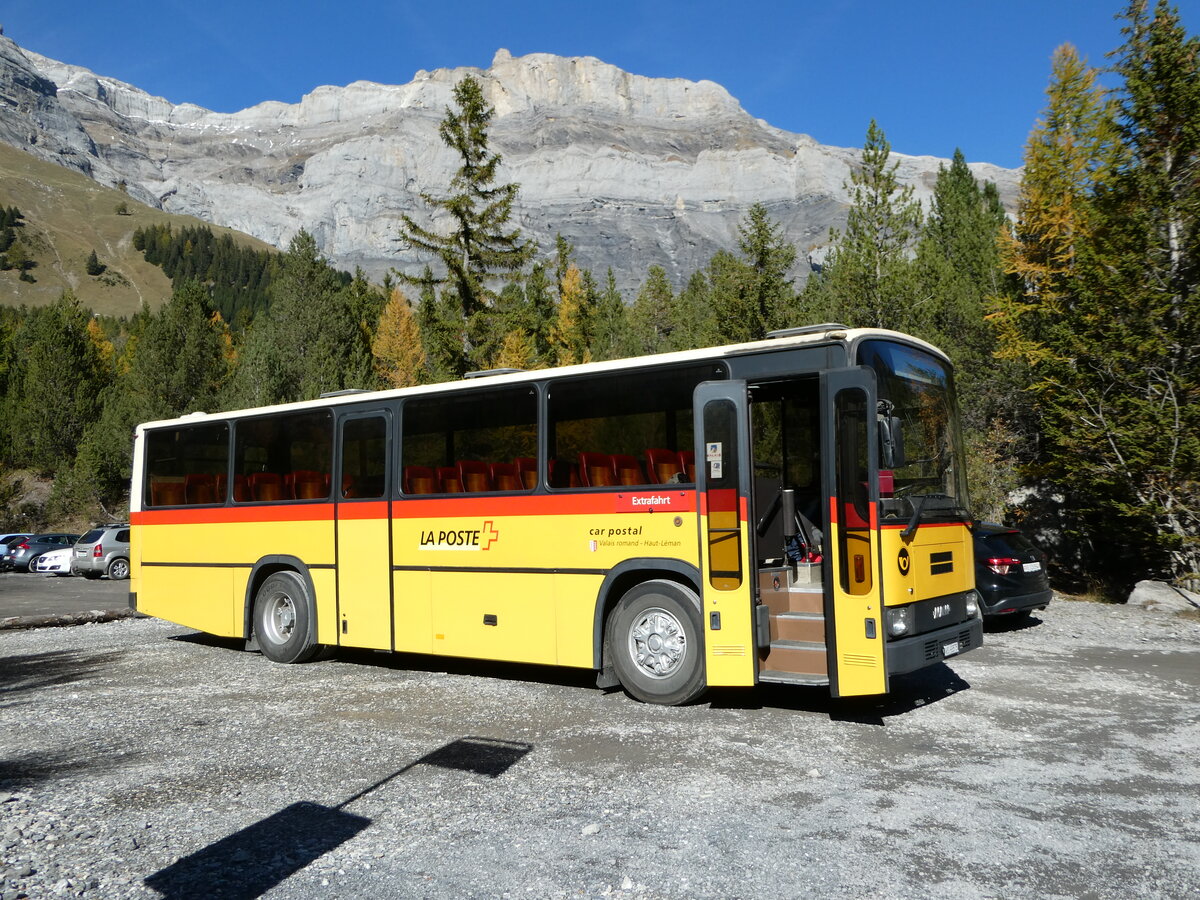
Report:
694,380,756,686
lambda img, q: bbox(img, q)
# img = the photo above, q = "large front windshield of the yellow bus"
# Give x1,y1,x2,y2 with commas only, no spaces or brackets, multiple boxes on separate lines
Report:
858,341,967,516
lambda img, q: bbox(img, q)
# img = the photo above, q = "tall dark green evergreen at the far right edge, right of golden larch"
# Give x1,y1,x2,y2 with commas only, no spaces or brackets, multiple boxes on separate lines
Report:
1084,0,1200,586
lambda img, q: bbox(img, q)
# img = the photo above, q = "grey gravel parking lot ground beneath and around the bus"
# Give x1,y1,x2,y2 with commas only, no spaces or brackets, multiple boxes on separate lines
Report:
0,600,1200,900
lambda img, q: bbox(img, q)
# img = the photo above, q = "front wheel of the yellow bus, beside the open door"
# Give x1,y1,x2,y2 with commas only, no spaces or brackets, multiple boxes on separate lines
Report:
607,580,708,706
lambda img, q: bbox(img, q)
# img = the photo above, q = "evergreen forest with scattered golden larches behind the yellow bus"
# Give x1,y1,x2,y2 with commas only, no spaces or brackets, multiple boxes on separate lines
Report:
0,0,1200,607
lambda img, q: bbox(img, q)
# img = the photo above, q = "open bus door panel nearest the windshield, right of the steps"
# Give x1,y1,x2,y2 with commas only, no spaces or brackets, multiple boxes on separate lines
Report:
821,368,888,697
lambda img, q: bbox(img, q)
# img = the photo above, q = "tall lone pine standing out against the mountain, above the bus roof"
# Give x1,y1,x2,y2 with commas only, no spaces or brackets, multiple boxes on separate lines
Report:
402,76,534,373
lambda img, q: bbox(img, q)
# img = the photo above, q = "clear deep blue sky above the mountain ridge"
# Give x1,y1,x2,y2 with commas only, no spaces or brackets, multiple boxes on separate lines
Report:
0,0,1200,166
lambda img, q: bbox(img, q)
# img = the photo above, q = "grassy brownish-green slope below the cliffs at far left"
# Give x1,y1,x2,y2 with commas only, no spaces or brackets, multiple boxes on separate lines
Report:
0,143,272,316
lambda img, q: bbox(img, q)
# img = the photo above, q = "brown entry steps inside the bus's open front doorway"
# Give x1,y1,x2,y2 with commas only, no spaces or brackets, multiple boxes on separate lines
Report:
758,566,829,684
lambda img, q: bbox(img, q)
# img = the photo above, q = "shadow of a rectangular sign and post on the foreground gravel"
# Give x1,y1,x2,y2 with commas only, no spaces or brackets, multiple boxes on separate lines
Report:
145,737,533,900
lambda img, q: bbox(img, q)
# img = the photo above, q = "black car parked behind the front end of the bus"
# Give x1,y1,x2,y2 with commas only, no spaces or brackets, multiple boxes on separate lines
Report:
974,522,1054,618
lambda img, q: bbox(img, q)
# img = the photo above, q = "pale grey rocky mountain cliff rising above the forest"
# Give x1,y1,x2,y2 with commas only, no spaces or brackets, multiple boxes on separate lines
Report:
0,36,1018,296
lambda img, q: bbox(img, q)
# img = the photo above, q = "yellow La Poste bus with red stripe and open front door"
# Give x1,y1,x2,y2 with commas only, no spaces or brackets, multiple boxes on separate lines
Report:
130,324,983,703
